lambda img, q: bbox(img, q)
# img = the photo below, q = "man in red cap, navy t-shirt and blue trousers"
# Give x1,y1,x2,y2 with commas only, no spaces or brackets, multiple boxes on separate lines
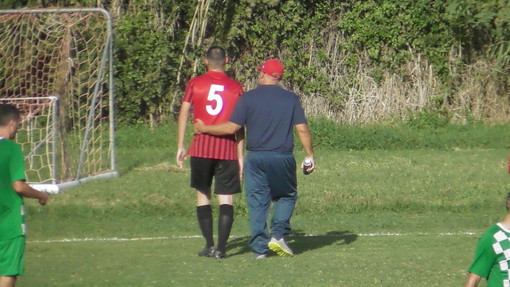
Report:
195,59,315,259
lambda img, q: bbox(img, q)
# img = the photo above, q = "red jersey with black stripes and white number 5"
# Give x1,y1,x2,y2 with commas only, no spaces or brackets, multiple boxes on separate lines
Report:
182,71,243,160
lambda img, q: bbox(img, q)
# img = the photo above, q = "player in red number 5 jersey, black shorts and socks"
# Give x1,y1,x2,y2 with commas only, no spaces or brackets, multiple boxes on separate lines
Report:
176,46,244,259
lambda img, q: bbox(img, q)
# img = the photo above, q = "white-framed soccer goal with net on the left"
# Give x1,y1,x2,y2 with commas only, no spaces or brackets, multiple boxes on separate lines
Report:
0,8,118,193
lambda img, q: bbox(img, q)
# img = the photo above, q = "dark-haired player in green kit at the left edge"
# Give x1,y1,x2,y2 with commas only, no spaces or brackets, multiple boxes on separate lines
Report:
0,104,48,287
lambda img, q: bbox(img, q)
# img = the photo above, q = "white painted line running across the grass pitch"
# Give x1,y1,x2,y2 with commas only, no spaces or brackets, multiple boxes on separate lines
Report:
28,231,478,243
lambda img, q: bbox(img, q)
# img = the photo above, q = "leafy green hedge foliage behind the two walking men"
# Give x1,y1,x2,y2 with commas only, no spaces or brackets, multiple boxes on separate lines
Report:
1,0,510,122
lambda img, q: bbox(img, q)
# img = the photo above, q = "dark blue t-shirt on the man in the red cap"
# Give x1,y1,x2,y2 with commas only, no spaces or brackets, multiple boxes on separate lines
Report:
230,85,307,152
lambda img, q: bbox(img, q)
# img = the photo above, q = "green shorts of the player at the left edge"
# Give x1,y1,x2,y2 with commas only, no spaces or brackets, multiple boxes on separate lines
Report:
0,236,25,276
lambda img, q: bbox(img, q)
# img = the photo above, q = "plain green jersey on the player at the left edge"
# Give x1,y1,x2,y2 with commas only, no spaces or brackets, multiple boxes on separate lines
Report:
0,138,25,241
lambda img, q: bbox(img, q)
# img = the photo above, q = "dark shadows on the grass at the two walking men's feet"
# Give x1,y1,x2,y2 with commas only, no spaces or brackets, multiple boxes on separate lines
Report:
227,230,358,256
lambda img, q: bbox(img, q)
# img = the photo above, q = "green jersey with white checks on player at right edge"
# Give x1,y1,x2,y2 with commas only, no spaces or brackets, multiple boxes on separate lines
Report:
469,223,510,287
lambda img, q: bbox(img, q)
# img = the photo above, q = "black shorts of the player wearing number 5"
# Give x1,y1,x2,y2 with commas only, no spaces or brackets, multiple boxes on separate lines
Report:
190,157,241,194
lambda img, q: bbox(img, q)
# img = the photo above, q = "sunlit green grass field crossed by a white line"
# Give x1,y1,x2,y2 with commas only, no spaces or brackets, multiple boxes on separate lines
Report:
18,122,510,287
